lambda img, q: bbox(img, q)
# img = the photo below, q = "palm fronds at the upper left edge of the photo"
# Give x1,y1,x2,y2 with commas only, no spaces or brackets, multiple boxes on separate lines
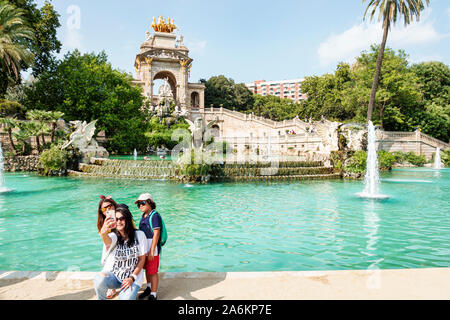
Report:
0,1,34,94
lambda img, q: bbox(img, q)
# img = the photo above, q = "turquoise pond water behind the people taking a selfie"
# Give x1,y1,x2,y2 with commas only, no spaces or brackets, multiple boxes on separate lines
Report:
0,168,450,272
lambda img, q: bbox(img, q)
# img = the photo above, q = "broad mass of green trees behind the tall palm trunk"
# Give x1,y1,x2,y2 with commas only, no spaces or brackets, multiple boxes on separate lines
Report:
298,46,450,141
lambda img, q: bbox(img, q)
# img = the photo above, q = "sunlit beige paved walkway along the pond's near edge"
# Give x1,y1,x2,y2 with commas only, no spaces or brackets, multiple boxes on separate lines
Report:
0,268,450,300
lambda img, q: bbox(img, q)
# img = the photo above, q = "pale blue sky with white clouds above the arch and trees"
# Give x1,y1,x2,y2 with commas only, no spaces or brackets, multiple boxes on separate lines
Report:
37,0,450,83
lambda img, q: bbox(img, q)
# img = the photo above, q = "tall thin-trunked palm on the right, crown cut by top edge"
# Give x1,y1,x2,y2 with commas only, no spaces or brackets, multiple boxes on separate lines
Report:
363,0,430,121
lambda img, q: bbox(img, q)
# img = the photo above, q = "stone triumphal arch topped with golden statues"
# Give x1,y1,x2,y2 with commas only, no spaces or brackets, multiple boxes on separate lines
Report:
134,17,205,119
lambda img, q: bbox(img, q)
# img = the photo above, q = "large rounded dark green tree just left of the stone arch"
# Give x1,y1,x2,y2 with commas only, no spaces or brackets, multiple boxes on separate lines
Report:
24,50,146,154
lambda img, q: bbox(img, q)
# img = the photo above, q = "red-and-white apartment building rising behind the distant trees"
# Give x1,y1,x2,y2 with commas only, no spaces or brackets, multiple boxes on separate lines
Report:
245,79,307,102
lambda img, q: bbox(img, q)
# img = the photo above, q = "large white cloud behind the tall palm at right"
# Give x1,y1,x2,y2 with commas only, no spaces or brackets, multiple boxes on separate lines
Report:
318,9,447,67
